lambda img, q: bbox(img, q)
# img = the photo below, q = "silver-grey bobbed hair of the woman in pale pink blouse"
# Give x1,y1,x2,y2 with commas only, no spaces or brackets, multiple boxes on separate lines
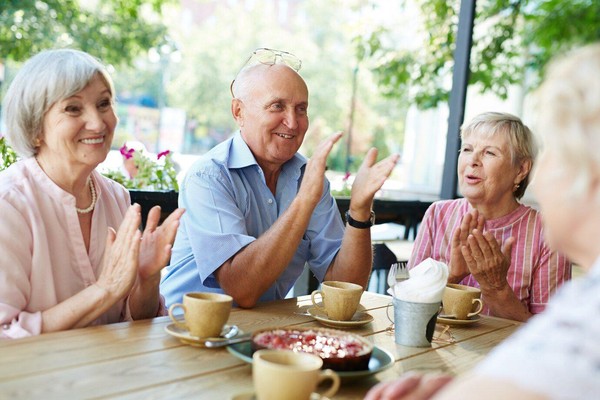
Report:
3,49,115,158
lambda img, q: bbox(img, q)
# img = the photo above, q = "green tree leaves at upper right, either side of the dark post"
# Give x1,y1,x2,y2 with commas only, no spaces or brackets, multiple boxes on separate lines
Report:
357,0,600,109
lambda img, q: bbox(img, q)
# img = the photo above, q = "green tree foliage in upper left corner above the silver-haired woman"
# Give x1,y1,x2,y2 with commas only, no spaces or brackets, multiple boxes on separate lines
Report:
0,0,171,65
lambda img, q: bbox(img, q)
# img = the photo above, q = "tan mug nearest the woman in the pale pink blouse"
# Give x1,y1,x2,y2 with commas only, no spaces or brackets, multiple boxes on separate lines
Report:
169,292,233,338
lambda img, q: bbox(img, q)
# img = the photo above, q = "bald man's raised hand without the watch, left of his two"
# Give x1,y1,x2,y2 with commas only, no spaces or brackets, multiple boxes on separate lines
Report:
298,132,342,206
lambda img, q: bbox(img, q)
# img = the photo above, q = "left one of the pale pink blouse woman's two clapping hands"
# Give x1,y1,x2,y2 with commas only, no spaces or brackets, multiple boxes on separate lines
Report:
96,205,141,300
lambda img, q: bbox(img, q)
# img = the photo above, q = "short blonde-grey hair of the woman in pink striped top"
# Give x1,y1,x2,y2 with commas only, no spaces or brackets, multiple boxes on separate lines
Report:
460,112,537,199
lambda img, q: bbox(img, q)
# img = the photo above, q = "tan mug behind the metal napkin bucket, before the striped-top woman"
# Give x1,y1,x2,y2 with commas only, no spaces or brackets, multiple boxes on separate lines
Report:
442,283,483,320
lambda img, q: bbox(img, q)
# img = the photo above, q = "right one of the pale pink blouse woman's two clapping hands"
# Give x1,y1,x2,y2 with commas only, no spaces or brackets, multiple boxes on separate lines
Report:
139,206,185,280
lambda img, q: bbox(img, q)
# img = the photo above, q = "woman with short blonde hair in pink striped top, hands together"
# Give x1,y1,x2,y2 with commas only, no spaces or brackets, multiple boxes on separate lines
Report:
408,112,571,321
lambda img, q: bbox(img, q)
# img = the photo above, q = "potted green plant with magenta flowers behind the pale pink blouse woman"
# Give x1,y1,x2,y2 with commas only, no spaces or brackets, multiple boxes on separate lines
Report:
103,145,179,192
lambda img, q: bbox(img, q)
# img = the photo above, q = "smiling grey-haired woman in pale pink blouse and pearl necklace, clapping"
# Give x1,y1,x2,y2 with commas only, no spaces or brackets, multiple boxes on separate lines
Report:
0,49,183,338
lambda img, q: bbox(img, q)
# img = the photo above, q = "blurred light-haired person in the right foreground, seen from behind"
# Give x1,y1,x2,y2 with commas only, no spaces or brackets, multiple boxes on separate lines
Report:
366,44,600,400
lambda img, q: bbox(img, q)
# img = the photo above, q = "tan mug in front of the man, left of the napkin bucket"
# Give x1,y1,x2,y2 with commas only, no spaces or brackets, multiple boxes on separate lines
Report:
311,281,363,321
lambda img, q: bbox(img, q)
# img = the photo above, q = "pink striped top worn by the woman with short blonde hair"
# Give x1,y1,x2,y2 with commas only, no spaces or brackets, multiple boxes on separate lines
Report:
408,199,571,315
